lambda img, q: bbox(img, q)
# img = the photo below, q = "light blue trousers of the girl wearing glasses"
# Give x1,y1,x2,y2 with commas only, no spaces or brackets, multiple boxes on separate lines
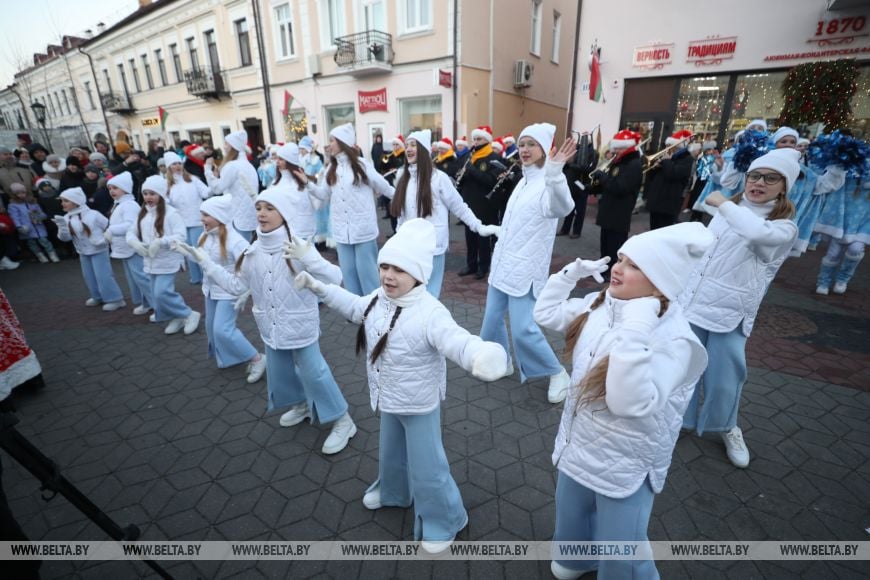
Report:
683,324,746,435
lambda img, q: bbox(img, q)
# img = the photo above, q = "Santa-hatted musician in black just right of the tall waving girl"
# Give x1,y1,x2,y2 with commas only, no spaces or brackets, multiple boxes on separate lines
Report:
591,129,643,279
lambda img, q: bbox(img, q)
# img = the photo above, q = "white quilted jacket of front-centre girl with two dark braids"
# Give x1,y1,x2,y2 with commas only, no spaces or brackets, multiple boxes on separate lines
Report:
324,285,498,415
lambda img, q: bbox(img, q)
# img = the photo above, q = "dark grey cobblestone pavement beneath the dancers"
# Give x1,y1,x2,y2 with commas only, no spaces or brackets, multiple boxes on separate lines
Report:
0,206,870,579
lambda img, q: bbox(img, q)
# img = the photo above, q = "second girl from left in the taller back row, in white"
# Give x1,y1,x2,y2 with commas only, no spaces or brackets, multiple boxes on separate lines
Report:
205,131,260,241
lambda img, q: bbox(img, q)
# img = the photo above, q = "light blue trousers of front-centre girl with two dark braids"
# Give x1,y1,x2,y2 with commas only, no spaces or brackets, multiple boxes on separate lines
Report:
369,407,467,542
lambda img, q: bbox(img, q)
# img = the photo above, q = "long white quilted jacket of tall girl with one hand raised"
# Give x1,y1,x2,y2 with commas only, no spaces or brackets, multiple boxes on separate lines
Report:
489,162,574,297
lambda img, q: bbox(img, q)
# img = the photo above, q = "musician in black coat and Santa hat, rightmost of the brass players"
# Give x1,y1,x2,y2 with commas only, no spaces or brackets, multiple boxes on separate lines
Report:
643,130,693,230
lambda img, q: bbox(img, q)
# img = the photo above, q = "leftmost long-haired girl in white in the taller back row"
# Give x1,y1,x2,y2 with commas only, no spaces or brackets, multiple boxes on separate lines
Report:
163,151,211,284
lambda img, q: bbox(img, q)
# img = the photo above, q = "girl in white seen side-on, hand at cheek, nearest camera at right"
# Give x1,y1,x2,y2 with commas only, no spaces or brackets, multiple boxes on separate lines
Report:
535,223,713,579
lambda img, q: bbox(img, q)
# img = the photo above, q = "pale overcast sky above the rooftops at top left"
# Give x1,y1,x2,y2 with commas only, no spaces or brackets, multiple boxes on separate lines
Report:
0,0,139,88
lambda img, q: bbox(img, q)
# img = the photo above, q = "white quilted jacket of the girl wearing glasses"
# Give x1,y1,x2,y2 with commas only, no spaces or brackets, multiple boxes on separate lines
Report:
679,199,797,336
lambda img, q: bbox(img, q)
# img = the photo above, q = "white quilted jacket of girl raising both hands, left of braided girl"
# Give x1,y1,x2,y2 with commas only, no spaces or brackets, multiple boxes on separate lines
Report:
205,227,341,350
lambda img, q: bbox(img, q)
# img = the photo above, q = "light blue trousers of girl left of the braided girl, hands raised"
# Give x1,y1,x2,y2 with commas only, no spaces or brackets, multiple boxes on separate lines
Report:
266,342,347,423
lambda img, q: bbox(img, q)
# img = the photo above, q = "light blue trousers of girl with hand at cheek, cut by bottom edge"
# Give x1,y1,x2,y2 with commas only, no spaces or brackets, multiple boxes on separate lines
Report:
553,471,659,580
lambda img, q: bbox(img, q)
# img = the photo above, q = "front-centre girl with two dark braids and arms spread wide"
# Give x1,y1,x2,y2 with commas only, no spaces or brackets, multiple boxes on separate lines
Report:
296,219,507,553
